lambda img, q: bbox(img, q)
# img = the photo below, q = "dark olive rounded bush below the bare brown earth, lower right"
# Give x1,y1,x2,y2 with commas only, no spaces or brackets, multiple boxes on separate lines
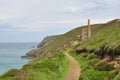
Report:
94,61,114,71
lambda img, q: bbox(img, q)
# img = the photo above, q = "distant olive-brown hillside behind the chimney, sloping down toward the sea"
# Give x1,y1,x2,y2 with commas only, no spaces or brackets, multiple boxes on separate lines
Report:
24,24,104,59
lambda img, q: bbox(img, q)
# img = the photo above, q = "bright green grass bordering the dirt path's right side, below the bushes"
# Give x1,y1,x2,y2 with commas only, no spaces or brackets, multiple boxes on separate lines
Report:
71,53,118,80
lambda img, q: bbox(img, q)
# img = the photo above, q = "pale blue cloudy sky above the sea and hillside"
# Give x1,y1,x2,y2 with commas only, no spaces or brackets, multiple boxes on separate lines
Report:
0,0,120,42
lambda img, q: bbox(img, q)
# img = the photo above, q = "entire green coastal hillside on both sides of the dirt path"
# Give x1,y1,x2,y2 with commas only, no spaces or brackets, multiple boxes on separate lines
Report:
0,20,120,80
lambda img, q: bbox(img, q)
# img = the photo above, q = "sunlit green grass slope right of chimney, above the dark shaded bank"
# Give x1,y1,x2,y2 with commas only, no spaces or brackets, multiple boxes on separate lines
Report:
78,22,120,49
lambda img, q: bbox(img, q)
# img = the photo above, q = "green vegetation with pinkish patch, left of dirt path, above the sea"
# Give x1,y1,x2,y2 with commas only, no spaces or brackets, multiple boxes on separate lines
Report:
0,52,69,80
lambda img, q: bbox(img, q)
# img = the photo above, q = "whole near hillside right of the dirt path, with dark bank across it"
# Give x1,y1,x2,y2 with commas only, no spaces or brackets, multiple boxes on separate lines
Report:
71,20,120,80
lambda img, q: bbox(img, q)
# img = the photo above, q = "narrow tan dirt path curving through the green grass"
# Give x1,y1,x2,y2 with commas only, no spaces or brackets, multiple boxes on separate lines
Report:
63,52,80,80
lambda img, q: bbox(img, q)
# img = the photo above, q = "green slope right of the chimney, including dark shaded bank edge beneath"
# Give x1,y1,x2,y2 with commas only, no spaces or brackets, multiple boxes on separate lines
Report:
76,21,120,57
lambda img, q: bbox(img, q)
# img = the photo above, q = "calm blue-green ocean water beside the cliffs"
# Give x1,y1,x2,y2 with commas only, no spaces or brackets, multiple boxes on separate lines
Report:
0,43,38,75
